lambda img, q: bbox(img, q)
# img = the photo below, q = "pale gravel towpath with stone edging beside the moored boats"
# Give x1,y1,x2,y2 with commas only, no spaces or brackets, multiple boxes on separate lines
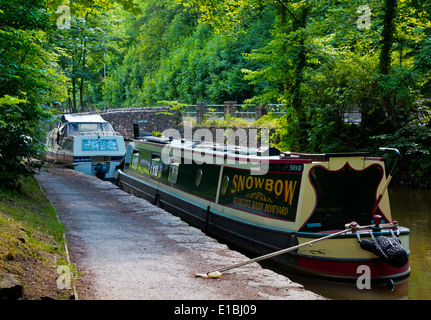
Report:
37,165,323,300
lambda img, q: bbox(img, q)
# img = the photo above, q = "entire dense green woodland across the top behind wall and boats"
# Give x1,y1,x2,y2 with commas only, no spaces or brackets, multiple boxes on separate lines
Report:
0,0,431,185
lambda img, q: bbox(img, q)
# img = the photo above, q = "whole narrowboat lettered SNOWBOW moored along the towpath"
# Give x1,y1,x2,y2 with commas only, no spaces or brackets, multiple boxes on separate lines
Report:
116,131,410,279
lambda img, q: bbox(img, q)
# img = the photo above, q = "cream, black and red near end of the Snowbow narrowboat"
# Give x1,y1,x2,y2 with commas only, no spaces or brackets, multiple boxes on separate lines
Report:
288,153,410,279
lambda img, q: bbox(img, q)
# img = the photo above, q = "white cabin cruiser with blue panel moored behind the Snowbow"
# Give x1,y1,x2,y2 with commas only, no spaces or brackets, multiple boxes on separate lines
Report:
44,114,126,180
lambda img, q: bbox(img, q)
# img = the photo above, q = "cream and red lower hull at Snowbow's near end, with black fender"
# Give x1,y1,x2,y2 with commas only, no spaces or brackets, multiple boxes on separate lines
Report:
294,224,410,280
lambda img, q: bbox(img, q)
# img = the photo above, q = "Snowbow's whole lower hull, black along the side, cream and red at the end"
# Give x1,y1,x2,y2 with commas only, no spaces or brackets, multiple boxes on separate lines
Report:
117,170,410,280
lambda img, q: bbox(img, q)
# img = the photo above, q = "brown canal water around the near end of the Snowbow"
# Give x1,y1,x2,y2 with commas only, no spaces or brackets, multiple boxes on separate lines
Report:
270,184,431,300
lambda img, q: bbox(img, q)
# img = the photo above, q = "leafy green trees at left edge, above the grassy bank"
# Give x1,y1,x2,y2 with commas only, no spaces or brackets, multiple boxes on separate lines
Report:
0,0,65,188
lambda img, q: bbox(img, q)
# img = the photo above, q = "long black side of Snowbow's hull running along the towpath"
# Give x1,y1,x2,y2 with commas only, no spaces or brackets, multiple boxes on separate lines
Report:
117,171,298,269
